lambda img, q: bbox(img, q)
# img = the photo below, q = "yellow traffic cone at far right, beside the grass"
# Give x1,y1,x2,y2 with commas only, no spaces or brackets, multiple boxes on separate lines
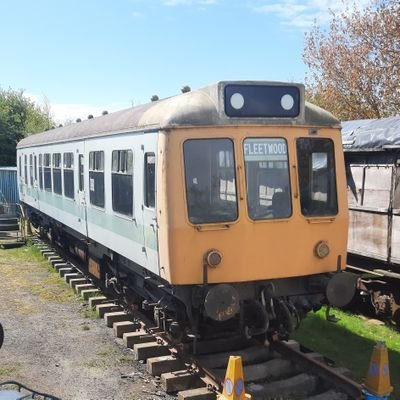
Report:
364,342,393,397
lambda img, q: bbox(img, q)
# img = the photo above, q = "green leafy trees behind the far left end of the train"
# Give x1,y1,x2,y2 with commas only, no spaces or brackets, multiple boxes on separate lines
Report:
0,89,52,166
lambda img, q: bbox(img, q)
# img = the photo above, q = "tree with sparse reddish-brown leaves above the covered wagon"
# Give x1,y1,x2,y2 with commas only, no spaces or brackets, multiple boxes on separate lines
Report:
303,0,400,120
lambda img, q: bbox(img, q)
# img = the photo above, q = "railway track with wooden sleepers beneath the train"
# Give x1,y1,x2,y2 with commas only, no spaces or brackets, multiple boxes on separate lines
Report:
32,237,363,400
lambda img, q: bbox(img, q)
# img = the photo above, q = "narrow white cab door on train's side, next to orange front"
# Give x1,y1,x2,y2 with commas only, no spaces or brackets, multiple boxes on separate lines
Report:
141,133,159,274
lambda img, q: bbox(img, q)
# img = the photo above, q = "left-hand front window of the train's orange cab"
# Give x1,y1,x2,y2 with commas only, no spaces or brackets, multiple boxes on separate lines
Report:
183,139,238,224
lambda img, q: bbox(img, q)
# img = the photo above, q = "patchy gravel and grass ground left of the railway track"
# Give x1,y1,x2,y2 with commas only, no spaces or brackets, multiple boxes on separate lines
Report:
0,246,169,400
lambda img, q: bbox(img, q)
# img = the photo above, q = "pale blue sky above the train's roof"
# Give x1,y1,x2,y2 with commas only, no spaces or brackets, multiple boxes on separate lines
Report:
0,0,362,122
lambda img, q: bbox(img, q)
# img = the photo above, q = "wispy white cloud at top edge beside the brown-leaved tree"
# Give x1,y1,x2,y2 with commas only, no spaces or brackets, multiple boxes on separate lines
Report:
253,0,369,29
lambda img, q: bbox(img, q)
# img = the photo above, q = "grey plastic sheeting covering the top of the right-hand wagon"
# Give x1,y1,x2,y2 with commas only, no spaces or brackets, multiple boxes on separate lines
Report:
342,117,400,151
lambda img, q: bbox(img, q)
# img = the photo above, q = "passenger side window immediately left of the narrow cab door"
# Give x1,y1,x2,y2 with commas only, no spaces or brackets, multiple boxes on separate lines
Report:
111,150,133,217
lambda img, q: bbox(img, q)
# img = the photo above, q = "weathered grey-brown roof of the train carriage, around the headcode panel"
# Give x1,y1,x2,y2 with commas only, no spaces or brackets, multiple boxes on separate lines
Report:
17,81,340,148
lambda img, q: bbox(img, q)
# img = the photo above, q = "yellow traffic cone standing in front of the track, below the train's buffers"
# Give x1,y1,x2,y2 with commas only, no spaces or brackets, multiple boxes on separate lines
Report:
218,356,251,400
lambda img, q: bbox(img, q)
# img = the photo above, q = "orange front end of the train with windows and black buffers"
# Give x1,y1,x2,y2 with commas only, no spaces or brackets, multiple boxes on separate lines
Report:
155,83,355,336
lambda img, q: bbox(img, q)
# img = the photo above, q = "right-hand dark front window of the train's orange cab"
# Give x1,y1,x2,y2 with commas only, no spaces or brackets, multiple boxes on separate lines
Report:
297,138,338,217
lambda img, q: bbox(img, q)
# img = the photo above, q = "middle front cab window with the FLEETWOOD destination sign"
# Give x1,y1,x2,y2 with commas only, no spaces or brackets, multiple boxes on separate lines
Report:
243,138,292,220
